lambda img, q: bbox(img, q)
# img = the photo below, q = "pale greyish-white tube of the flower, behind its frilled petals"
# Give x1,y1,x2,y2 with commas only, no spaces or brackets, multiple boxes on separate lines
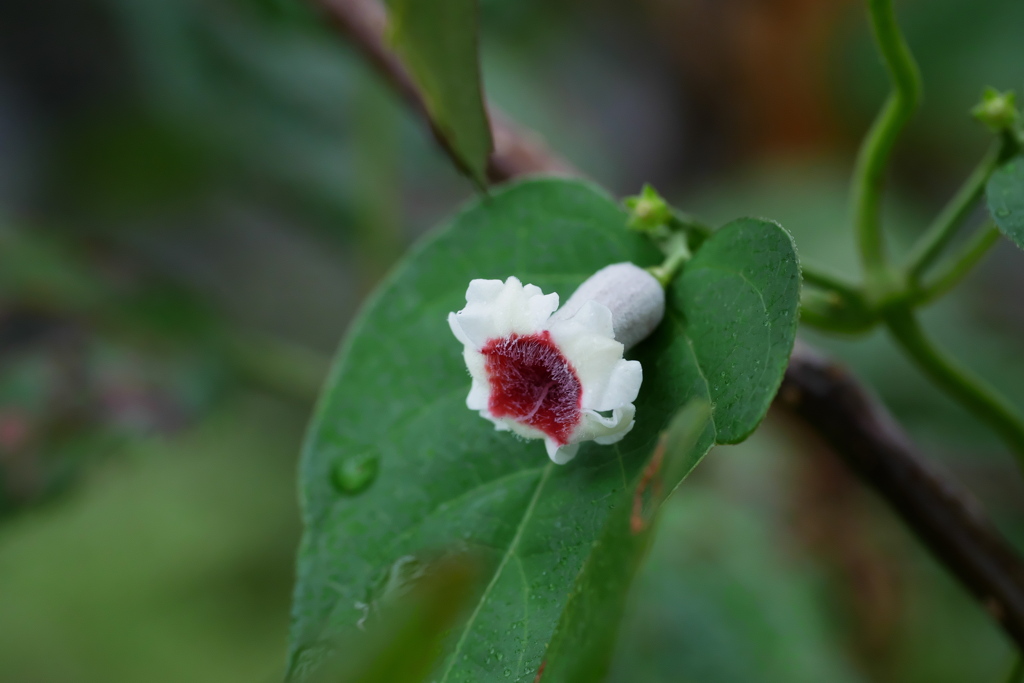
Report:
552,263,665,349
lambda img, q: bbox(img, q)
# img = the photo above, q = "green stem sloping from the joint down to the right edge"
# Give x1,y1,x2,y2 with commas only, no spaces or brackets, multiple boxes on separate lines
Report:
886,307,1024,467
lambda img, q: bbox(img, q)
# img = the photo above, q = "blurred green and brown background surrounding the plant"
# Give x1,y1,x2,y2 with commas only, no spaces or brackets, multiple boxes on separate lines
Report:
0,0,1024,683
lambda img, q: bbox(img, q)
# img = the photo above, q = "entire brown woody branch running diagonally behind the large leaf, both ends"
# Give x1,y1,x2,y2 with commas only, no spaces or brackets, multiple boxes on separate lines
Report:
313,0,1024,648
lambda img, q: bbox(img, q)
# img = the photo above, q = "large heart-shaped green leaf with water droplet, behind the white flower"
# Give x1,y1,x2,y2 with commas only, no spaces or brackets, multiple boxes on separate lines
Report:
291,179,800,683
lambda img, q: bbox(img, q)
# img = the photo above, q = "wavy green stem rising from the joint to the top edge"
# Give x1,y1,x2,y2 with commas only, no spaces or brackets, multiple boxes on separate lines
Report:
852,0,921,288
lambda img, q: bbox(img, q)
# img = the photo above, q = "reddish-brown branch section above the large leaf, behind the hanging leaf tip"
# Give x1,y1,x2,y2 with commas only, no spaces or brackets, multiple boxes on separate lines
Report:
312,0,582,182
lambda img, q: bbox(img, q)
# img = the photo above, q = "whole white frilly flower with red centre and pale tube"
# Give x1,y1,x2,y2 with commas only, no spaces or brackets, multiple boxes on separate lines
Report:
449,263,665,465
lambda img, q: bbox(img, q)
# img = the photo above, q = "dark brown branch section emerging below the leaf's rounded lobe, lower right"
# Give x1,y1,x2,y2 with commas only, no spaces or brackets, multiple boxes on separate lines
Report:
777,342,1024,647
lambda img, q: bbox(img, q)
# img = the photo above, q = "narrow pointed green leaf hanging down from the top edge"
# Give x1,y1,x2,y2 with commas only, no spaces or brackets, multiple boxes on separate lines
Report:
387,0,492,186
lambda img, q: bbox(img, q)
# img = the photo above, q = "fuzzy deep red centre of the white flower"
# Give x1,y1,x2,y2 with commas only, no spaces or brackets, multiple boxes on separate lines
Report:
483,331,583,445
